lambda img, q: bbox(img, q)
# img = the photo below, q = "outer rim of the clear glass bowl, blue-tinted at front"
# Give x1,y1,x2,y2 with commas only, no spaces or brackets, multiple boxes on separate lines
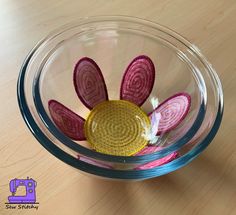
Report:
17,16,223,179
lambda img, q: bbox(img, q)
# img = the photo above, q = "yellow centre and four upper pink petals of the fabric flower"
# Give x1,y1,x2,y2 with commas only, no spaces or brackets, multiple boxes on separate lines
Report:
48,55,191,156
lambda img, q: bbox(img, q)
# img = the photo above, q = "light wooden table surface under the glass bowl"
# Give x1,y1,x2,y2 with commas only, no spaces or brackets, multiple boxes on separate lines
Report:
0,0,236,215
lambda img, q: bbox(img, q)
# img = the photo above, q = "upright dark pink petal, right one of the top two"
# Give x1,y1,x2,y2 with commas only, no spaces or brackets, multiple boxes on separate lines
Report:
120,55,155,106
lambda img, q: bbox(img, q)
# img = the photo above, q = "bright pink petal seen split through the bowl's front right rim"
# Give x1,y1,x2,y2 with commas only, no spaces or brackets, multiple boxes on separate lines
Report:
135,146,179,170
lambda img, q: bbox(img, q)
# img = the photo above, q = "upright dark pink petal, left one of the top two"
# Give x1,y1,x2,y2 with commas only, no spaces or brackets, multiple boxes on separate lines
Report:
73,57,108,109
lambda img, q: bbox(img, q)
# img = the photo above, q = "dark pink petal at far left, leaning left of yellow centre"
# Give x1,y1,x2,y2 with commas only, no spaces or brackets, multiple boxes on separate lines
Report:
48,100,86,140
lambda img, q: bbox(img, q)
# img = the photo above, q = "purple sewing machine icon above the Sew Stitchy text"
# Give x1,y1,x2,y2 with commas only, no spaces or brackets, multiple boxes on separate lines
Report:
8,177,37,204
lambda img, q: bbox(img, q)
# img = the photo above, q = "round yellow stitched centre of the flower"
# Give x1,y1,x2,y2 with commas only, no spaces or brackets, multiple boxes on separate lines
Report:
84,100,150,156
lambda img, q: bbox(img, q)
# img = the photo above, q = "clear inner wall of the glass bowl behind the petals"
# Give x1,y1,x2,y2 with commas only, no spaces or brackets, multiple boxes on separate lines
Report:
38,24,202,155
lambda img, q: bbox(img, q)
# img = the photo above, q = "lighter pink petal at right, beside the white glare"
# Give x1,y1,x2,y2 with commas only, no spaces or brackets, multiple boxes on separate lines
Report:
148,93,191,134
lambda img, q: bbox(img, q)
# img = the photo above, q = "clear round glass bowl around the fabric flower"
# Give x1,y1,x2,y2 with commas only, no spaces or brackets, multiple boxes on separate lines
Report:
17,16,223,180
